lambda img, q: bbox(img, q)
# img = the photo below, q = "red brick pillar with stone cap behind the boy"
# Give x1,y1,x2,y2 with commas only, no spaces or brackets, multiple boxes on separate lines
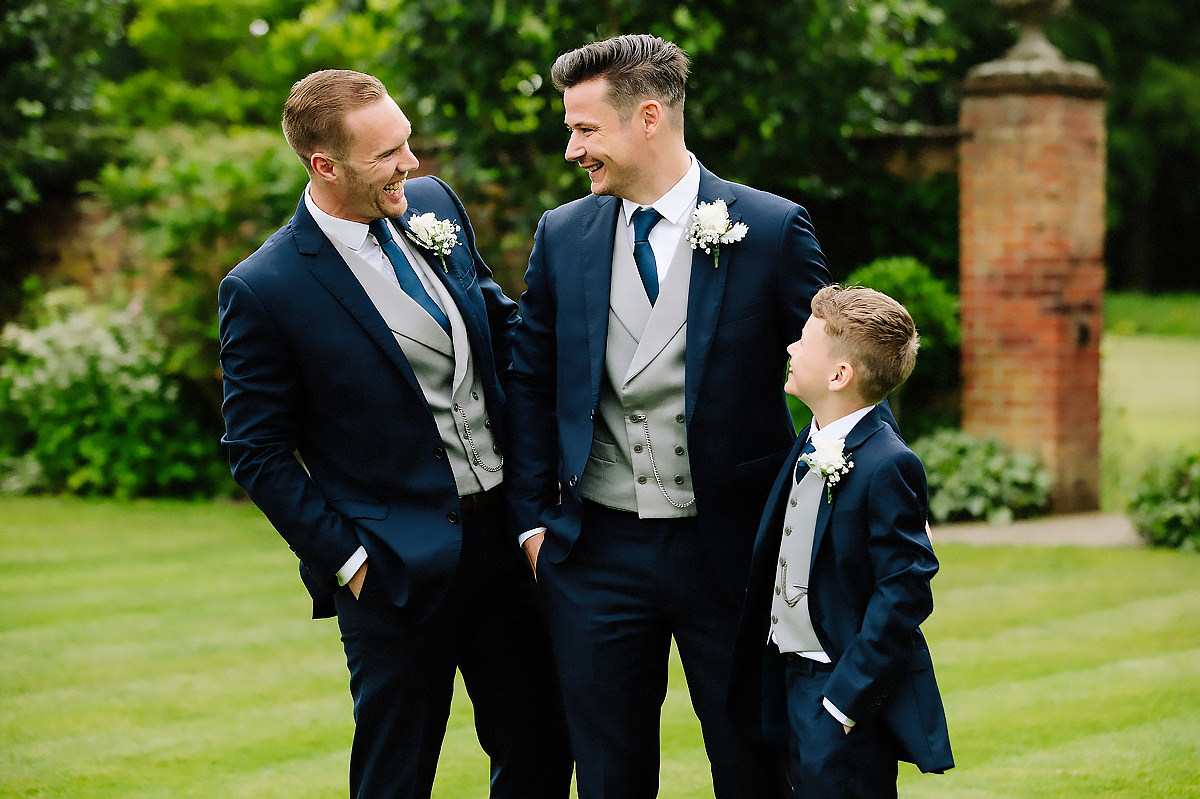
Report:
959,0,1106,512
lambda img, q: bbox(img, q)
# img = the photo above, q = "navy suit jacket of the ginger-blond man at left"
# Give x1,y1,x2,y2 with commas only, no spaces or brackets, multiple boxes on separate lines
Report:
220,178,517,617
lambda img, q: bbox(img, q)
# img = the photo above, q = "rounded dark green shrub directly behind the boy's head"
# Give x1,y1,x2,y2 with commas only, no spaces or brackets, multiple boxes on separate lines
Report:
846,257,962,440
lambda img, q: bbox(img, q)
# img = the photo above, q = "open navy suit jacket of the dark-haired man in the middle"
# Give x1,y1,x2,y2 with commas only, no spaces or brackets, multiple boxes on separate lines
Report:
505,168,829,597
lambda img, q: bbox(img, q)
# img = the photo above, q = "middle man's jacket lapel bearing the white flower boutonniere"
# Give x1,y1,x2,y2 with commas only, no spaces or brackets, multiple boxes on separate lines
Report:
684,166,742,422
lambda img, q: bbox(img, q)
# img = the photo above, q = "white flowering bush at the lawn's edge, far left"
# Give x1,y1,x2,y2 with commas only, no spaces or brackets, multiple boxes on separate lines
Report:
0,289,227,498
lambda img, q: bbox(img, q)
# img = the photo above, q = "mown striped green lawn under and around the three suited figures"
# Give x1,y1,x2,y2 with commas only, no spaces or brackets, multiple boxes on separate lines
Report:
0,499,1200,799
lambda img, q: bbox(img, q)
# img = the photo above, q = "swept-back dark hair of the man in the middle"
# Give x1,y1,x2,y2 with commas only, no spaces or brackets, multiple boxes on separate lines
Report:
550,34,691,124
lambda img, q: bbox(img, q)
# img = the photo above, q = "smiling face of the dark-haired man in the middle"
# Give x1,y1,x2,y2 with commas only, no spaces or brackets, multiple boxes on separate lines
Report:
563,78,659,204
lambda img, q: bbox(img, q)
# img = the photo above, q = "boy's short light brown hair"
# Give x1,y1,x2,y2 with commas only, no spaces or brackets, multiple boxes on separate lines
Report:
812,286,920,404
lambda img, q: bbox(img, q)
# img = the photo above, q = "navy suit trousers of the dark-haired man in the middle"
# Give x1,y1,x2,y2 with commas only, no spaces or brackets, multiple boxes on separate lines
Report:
538,503,787,799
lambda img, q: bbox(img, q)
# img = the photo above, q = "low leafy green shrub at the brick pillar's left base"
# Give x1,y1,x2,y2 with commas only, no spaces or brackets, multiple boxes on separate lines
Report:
912,429,1050,524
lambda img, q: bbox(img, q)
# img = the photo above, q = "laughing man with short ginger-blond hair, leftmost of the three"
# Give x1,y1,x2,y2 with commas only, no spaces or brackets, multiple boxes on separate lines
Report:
220,70,571,799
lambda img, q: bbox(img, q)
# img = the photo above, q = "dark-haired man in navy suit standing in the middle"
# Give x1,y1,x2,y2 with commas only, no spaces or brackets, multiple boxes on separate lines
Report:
506,35,829,799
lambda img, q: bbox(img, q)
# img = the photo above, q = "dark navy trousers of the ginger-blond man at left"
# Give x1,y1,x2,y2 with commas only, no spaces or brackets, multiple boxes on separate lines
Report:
335,494,571,799
